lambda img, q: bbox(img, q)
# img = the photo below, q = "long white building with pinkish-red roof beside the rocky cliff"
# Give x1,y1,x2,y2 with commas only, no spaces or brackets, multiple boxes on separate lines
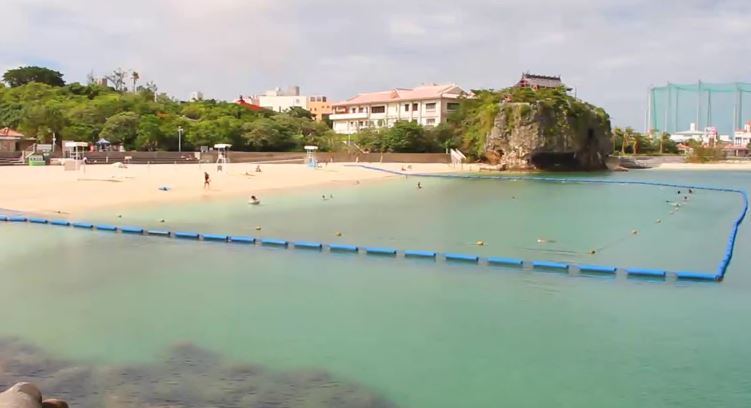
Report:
329,84,467,134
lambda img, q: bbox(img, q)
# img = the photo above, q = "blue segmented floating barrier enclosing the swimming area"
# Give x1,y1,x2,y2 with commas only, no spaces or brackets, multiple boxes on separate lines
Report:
0,165,749,282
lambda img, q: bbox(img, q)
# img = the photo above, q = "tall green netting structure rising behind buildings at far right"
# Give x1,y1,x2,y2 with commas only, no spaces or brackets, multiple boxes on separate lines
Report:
647,81,751,136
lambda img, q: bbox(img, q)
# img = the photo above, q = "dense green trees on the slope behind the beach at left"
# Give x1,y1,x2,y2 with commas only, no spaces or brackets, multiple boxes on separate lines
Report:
0,67,334,151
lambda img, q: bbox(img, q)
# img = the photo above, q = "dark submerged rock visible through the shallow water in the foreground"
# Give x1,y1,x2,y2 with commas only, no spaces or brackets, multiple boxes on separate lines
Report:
0,339,394,408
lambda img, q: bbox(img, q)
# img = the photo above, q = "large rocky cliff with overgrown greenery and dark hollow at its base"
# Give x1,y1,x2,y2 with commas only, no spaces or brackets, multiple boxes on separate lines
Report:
485,97,612,170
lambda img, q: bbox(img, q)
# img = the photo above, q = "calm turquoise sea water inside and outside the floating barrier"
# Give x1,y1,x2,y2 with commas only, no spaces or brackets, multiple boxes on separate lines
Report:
0,171,751,407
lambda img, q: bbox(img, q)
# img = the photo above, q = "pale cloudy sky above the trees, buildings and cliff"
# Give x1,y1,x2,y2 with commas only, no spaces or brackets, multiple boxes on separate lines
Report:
0,0,751,129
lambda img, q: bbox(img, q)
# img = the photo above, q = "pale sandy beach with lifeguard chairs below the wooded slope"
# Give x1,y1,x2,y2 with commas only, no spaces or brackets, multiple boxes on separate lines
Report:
0,163,454,216
